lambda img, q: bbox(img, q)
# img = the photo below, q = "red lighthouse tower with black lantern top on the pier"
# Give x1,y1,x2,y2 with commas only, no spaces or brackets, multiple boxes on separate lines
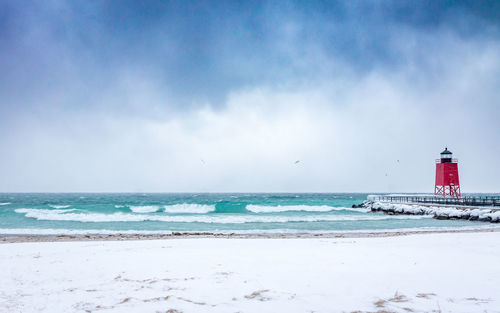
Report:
434,148,460,198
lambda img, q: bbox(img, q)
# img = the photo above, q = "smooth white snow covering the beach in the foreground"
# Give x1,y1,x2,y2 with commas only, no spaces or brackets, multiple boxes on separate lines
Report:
0,232,500,312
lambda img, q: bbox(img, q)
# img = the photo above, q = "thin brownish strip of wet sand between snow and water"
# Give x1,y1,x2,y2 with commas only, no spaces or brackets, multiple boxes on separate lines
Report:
0,227,500,244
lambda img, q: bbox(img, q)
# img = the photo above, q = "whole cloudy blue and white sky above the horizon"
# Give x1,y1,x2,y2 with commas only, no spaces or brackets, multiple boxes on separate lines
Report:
0,0,500,193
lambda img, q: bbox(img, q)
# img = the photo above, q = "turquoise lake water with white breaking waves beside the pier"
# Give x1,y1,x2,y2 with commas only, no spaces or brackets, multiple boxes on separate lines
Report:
0,193,484,234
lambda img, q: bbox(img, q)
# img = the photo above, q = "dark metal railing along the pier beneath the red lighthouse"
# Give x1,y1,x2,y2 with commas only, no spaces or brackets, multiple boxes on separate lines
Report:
373,196,500,206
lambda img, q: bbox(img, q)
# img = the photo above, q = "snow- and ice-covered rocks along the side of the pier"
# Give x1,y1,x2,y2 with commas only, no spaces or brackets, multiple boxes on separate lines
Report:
360,200,500,223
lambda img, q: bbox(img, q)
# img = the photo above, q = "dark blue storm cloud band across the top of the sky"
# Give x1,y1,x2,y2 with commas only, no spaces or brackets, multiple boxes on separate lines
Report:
0,1,500,110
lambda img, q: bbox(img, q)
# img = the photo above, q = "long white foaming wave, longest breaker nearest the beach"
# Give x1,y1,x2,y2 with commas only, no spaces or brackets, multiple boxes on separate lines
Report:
15,209,432,224
